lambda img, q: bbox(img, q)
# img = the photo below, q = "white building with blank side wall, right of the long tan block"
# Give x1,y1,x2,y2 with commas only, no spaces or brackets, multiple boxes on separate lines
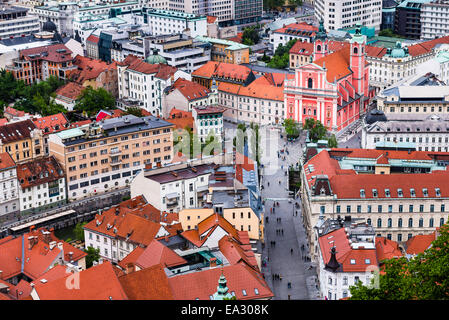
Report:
131,164,215,212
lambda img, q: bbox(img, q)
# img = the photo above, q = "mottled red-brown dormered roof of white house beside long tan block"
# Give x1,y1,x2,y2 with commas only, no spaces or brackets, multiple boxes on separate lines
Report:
17,156,64,189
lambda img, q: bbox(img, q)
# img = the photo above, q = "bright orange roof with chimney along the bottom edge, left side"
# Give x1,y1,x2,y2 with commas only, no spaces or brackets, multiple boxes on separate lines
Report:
35,261,128,300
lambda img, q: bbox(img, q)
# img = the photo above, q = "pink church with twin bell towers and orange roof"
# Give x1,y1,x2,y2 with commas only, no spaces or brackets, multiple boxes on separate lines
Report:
284,26,375,132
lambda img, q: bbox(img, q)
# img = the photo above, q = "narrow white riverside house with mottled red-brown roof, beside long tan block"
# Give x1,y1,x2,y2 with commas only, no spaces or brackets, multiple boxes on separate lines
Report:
17,156,67,213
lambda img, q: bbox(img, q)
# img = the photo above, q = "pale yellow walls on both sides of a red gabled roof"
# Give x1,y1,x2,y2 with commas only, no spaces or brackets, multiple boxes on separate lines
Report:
179,207,264,240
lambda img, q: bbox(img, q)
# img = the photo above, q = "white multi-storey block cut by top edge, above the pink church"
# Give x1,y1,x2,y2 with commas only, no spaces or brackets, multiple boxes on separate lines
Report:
314,0,382,31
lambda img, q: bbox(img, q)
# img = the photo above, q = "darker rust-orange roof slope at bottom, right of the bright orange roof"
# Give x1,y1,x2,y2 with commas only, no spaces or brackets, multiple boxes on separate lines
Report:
119,264,174,300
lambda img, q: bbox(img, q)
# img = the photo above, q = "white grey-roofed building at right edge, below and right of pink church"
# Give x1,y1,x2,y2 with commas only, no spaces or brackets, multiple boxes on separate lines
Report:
361,109,449,152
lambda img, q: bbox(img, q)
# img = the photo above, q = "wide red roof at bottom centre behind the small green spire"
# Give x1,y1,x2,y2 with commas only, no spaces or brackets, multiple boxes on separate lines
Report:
168,263,274,300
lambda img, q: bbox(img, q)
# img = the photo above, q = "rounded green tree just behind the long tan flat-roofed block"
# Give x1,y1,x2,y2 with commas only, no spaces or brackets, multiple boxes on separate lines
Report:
74,86,115,116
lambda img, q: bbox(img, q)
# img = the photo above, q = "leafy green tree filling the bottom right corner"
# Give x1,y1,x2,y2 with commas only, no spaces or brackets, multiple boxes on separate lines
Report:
350,223,449,300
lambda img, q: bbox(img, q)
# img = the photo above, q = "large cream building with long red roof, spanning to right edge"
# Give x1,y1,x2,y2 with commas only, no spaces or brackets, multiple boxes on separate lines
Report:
301,146,449,260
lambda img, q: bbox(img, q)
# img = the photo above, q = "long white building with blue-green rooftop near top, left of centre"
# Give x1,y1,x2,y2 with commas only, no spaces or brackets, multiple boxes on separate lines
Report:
136,8,207,38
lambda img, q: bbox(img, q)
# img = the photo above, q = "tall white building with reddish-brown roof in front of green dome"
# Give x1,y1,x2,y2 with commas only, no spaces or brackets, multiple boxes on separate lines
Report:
117,55,177,116
